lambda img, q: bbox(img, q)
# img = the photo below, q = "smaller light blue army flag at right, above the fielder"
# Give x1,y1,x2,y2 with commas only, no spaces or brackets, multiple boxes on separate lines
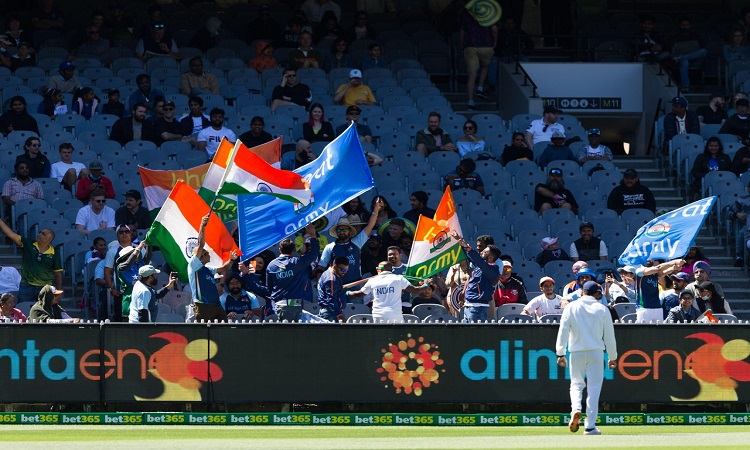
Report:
618,197,716,267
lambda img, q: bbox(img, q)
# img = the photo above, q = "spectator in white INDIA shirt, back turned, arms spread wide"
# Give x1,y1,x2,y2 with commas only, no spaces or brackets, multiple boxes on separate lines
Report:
346,261,429,322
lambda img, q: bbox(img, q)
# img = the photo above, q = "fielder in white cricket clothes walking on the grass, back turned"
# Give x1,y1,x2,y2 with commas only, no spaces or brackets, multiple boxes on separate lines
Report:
555,281,617,435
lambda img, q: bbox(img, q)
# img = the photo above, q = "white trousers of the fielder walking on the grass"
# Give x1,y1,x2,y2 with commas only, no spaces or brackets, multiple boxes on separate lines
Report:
570,350,604,430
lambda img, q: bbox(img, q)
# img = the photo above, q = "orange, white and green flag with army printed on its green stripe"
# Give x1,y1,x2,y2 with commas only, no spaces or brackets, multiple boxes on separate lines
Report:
406,186,466,278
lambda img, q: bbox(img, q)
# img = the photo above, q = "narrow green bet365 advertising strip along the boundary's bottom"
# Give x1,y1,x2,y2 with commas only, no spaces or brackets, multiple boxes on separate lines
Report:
0,412,750,427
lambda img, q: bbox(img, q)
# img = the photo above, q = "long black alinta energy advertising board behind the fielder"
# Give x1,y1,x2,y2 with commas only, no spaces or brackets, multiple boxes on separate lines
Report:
0,324,750,404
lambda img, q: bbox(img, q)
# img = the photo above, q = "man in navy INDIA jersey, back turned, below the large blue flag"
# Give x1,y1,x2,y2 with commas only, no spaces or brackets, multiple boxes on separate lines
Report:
266,223,320,322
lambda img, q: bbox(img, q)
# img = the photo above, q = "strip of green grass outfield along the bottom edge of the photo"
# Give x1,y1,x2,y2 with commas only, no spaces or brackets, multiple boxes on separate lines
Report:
0,425,750,450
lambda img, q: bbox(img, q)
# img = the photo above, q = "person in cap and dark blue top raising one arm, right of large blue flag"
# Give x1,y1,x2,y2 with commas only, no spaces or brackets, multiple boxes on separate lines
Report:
318,203,382,284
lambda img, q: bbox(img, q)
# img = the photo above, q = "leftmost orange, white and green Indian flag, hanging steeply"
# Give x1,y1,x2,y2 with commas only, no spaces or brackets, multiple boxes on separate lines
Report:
146,181,240,282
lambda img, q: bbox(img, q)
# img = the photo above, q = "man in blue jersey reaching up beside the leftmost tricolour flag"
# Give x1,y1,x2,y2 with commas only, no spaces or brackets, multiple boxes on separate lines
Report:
188,212,238,322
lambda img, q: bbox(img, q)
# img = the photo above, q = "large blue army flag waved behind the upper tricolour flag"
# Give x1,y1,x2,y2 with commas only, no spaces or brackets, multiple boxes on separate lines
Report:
237,126,375,256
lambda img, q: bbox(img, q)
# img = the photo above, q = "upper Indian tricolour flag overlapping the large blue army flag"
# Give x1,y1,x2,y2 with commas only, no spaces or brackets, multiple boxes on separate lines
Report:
213,140,312,205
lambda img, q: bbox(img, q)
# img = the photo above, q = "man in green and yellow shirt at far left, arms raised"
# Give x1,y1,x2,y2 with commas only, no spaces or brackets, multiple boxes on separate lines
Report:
0,219,63,302
